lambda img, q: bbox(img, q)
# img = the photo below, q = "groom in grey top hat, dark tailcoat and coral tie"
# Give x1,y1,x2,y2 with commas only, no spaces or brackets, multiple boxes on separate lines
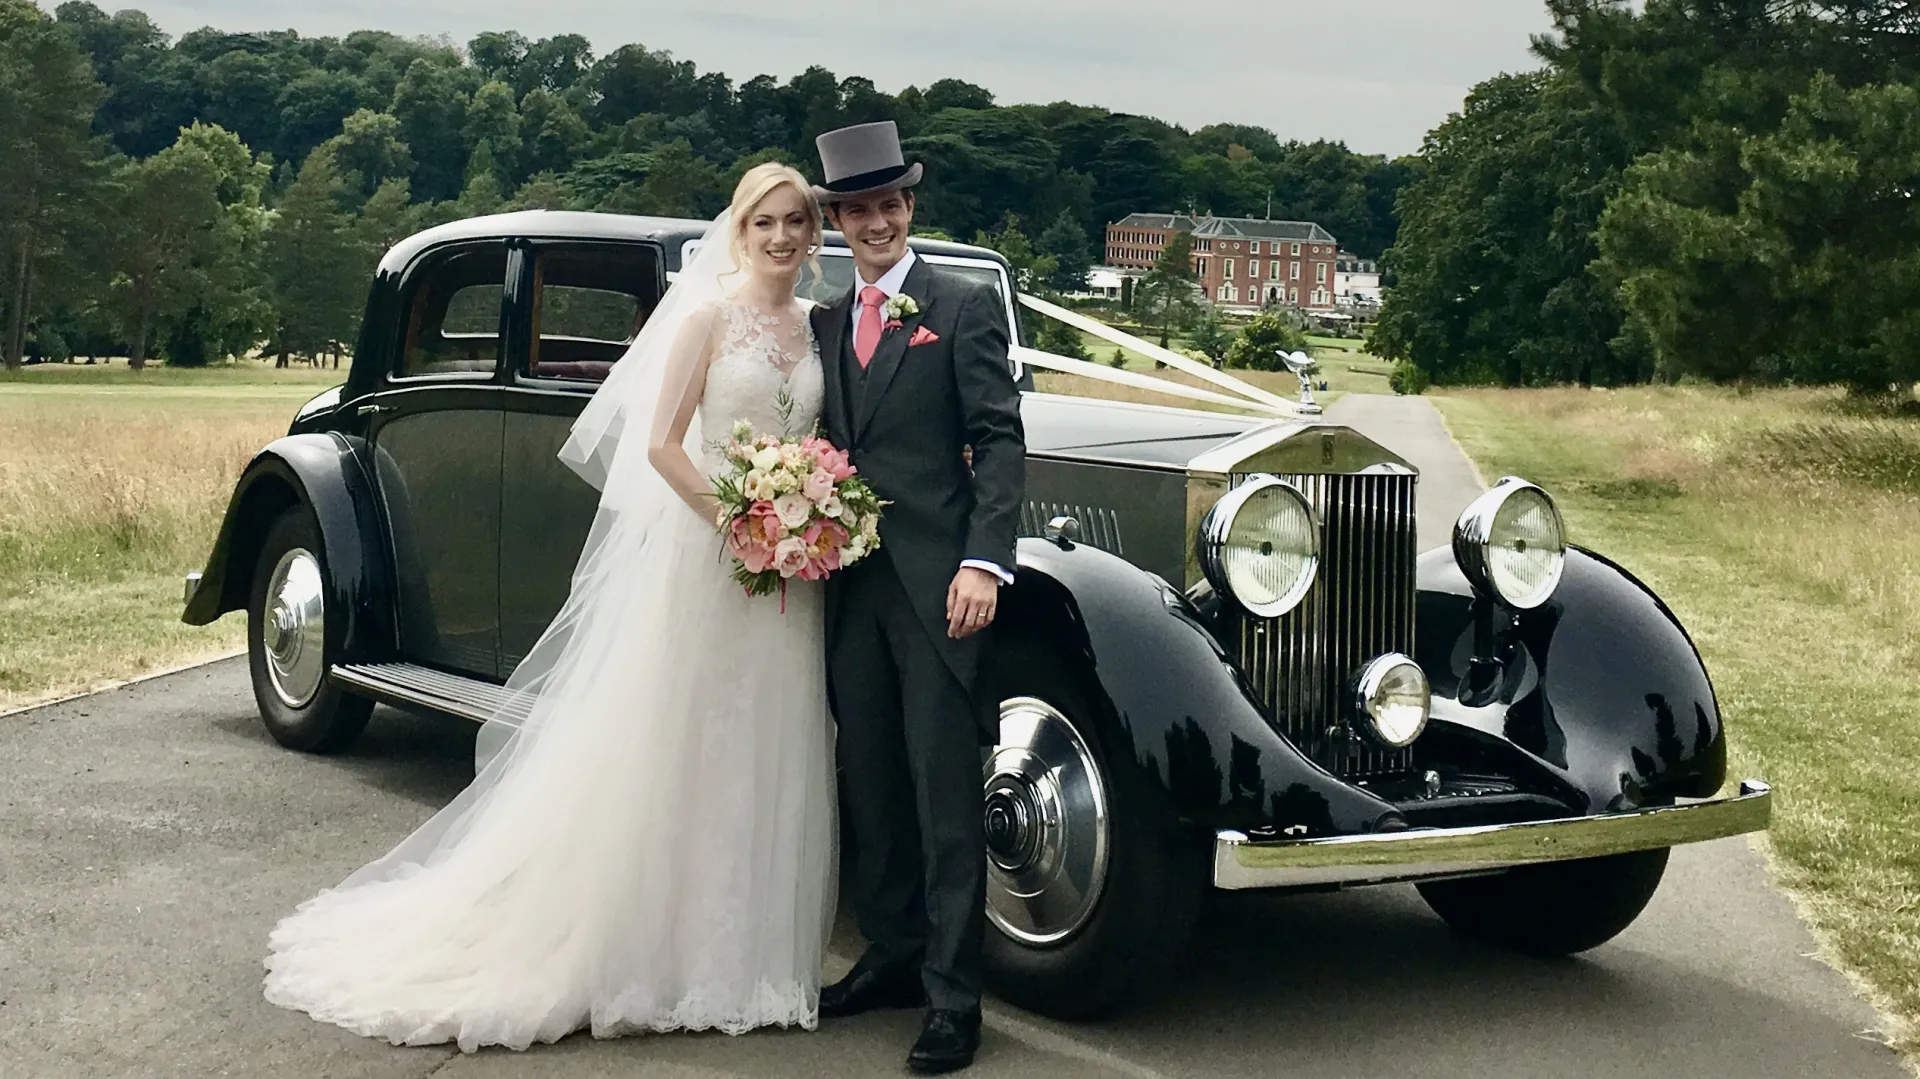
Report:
812,123,1025,1073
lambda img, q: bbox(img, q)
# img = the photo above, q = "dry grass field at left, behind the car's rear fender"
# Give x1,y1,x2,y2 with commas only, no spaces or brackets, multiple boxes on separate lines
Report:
0,367,338,710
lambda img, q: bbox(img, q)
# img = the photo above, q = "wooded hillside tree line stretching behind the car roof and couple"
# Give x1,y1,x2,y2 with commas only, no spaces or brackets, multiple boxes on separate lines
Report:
0,0,1417,367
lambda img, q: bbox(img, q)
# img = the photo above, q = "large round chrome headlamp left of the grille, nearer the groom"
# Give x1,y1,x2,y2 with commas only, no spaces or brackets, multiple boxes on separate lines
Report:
1198,476,1319,618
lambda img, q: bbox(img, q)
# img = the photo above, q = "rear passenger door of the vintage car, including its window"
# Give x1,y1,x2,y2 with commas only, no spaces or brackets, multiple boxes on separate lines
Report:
357,240,509,678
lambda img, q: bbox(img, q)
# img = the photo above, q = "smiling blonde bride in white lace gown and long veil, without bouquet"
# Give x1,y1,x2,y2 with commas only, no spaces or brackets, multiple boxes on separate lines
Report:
265,163,833,1052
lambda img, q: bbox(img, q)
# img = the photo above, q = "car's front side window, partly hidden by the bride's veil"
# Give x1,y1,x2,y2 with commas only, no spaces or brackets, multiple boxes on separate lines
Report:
526,244,659,382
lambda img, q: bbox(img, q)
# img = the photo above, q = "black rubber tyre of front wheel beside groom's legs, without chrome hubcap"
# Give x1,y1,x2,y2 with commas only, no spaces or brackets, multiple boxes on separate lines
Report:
985,641,1208,1019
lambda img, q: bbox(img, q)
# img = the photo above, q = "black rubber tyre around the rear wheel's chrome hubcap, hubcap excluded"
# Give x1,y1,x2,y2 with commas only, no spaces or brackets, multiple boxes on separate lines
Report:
246,505,372,753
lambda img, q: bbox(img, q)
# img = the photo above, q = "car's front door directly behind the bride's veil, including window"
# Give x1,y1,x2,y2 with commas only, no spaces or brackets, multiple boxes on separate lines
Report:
499,240,666,674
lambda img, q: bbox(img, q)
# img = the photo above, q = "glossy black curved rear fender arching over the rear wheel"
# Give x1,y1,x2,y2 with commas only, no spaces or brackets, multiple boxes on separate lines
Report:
180,432,394,662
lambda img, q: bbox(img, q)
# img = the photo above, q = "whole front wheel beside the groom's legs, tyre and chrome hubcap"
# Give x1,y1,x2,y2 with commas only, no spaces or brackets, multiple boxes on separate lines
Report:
983,643,1206,1019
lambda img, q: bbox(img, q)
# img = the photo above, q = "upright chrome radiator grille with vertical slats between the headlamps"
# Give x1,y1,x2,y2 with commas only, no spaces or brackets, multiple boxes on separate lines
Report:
1233,474,1419,778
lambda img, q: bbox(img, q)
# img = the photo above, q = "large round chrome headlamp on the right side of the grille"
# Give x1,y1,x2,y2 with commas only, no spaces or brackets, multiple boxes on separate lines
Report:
1453,476,1567,611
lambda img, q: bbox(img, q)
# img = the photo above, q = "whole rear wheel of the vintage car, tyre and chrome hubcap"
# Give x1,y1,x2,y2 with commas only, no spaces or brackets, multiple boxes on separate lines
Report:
246,505,372,753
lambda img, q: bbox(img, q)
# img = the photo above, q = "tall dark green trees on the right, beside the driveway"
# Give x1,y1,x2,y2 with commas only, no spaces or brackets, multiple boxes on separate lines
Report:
1371,0,1920,394
